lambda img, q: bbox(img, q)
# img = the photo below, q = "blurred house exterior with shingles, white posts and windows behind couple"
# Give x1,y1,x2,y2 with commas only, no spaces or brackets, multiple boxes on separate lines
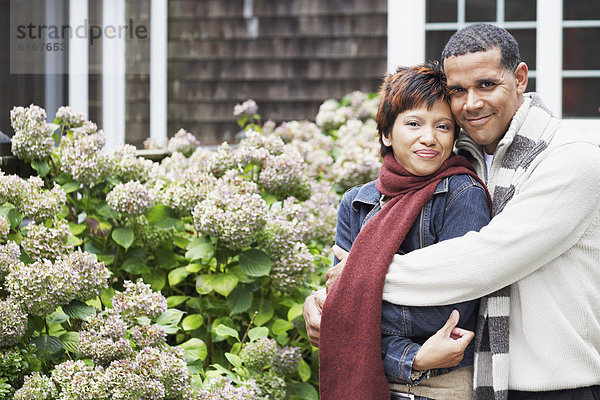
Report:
0,0,600,148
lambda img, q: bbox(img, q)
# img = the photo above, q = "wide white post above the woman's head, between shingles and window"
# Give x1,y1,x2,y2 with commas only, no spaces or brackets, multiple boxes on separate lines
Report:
387,0,425,73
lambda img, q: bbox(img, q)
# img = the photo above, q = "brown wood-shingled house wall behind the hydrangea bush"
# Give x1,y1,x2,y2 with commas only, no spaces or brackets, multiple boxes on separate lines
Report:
126,0,387,146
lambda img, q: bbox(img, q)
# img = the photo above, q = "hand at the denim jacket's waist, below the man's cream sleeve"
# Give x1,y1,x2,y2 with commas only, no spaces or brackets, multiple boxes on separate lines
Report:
413,310,475,371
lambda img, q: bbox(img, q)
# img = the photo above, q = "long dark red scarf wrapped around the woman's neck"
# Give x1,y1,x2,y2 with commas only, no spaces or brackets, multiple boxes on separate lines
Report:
319,153,489,400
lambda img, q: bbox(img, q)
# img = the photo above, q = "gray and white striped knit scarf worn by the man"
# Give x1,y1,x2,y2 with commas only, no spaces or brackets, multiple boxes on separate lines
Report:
464,93,558,400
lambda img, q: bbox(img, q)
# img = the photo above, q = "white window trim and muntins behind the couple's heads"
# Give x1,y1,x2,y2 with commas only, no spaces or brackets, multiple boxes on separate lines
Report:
387,0,600,138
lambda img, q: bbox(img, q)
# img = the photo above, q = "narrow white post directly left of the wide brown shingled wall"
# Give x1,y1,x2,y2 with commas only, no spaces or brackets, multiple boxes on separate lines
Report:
150,0,168,144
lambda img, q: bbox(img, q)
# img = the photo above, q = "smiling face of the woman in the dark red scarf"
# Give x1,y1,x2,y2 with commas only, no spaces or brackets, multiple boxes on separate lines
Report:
383,100,454,176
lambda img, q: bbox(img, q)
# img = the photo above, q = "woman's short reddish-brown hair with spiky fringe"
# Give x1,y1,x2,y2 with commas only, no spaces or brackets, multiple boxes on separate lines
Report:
375,61,460,157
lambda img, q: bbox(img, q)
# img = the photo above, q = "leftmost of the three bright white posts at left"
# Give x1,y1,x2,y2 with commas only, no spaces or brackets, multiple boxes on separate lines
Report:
67,1,90,117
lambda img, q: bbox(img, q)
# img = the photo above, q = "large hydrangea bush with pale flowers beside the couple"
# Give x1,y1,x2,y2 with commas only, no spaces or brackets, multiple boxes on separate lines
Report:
0,92,379,399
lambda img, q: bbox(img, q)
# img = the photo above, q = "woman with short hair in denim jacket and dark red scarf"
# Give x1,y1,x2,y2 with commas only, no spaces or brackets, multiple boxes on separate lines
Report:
319,63,490,400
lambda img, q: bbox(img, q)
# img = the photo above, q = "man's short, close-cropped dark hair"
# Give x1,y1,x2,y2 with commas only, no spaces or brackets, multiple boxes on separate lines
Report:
442,24,521,72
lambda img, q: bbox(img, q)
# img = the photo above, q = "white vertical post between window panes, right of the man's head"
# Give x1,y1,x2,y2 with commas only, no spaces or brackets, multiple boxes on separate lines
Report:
536,0,563,117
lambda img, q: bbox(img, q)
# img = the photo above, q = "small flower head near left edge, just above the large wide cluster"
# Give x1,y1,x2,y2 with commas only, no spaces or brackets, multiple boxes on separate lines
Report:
21,218,73,260
